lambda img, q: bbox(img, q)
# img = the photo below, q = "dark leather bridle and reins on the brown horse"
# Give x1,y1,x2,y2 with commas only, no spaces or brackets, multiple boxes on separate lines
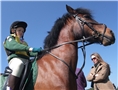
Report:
43,14,110,79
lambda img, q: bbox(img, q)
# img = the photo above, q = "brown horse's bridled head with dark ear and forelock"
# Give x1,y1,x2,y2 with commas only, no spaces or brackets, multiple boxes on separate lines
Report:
66,5,115,46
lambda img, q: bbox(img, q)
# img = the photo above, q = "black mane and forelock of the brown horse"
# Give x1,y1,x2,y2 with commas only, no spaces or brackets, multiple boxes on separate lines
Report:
44,8,92,48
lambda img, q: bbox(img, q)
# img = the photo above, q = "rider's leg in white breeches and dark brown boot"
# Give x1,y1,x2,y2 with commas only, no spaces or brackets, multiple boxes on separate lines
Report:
8,58,27,90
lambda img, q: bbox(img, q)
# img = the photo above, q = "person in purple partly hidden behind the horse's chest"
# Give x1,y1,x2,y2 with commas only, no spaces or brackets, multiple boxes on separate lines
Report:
75,68,87,90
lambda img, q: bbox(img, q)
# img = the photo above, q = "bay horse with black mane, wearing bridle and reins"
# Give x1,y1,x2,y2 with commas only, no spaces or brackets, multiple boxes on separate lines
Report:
34,5,115,90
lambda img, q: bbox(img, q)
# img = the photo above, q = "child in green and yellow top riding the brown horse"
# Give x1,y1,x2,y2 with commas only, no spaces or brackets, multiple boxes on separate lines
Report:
4,21,42,90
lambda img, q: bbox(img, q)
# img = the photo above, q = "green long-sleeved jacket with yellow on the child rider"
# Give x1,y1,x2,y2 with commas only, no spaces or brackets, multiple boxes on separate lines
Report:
4,35,37,62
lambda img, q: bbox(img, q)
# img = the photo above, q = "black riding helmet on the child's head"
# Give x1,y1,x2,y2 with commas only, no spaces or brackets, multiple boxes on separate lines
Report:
10,21,27,34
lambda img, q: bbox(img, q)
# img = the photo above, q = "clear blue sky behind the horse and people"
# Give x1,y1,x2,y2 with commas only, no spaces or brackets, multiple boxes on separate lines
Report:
0,1,118,88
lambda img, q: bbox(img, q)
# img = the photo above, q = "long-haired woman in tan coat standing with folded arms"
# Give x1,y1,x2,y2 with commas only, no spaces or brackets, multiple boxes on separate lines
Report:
87,53,115,90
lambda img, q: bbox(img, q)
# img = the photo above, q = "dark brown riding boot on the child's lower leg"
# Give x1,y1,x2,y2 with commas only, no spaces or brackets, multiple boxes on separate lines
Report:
8,75,20,90
